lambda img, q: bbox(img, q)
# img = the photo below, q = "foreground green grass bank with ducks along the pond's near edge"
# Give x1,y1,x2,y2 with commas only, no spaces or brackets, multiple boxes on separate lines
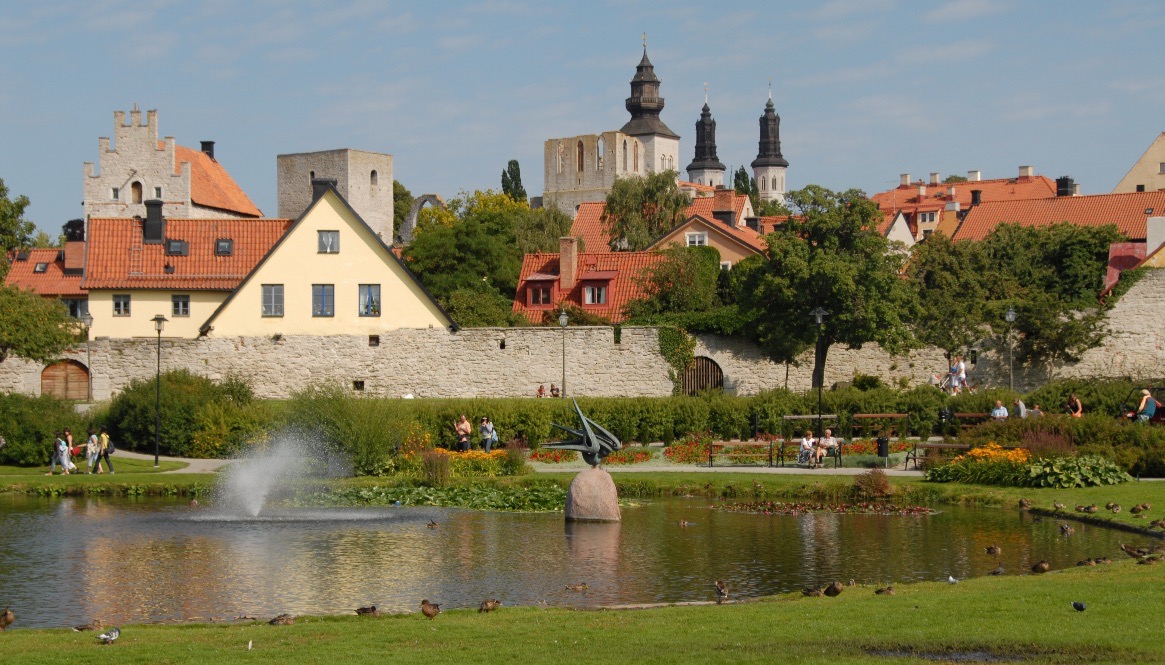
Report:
0,559,1165,665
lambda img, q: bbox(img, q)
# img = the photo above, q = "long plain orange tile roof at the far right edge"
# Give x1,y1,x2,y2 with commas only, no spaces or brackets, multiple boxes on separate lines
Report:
954,191,1165,242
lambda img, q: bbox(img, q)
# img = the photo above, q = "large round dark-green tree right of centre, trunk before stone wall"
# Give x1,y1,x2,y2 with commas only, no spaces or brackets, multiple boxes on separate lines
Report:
737,185,913,385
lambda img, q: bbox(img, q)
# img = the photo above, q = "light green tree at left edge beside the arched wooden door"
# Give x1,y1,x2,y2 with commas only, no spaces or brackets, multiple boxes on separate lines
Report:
0,284,77,363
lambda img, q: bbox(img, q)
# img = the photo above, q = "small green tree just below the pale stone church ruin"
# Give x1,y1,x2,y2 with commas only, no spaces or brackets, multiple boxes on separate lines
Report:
602,171,689,252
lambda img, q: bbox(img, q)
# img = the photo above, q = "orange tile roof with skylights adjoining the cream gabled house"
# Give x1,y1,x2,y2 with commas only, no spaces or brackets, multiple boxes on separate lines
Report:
82,219,292,291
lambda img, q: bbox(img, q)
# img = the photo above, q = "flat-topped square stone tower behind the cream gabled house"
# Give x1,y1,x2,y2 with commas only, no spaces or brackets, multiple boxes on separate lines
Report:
275,148,393,245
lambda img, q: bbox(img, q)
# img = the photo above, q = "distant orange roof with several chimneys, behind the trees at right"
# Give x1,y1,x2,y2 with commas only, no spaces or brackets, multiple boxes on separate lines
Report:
870,176,1055,217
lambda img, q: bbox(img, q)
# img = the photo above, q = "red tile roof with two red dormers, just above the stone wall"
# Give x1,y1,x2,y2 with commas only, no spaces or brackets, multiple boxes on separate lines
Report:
514,249,663,323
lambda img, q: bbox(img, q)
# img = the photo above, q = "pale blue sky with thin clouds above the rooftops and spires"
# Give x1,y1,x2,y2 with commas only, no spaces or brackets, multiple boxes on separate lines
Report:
0,0,1165,235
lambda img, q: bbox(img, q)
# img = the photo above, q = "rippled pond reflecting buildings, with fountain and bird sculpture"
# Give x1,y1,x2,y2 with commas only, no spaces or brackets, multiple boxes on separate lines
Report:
0,496,1143,628
